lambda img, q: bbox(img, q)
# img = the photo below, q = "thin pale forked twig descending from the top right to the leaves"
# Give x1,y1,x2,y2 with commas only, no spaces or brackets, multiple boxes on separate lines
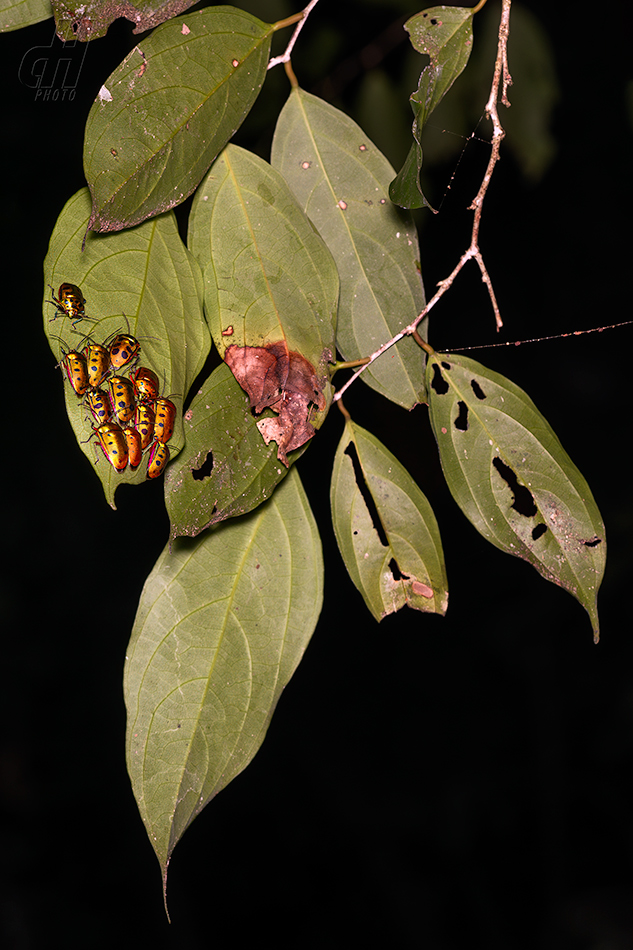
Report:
334,0,512,401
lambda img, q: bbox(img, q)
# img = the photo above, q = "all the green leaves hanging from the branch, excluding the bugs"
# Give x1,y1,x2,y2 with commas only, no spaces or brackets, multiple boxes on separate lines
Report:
21,5,606,896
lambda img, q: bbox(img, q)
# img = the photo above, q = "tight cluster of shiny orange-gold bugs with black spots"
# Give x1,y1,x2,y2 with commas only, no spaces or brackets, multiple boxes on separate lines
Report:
53,300,177,478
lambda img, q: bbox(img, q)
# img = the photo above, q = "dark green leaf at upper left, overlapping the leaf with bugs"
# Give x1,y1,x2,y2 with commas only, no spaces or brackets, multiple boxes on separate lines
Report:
84,6,273,231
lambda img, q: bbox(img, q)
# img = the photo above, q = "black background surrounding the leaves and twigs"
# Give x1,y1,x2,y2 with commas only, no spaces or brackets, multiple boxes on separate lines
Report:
0,0,633,950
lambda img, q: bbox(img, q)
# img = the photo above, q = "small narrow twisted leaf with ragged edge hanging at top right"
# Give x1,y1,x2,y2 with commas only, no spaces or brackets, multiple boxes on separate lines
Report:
389,6,473,211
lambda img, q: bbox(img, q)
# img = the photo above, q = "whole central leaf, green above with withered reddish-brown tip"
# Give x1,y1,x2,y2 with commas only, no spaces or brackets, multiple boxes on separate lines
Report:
189,145,339,465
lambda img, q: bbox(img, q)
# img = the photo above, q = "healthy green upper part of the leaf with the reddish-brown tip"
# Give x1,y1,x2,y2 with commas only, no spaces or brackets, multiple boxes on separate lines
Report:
188,145,339,384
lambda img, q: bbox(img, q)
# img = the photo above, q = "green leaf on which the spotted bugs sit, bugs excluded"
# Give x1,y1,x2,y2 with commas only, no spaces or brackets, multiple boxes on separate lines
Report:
43,188,211,507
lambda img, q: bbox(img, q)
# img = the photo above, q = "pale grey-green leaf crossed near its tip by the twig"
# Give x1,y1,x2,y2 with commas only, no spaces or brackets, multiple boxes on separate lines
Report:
271,88,426,409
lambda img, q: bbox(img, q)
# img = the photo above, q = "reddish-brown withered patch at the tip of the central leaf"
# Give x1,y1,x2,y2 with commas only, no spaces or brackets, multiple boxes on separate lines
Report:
224,341,325,468
